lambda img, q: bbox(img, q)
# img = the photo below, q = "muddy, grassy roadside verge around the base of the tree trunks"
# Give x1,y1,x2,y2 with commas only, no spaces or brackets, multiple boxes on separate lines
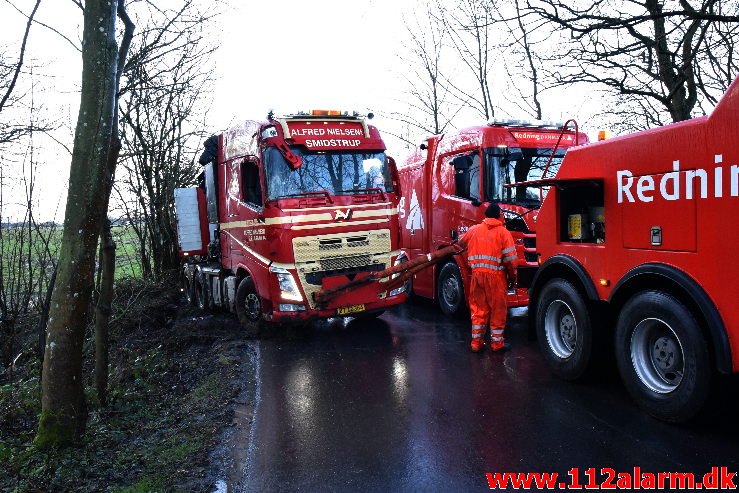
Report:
0,280,258,492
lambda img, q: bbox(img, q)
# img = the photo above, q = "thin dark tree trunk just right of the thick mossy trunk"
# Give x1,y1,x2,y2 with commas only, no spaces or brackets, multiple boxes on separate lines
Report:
95,221,115,407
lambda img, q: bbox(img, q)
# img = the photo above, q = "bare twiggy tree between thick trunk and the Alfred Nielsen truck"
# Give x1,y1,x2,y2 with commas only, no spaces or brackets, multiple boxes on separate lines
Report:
117,0,215,280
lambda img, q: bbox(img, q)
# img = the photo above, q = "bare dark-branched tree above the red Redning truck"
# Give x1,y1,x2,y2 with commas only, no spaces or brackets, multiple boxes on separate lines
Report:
527,0,739,129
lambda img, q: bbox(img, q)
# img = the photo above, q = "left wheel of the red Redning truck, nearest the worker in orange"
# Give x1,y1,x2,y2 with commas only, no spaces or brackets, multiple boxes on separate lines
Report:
536,279,593,380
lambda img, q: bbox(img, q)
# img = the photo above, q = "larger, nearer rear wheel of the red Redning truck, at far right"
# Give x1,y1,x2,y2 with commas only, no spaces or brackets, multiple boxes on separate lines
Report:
615,291,711,423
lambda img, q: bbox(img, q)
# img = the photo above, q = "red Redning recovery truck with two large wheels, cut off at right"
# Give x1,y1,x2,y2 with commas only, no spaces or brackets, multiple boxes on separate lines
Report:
529,78,739,422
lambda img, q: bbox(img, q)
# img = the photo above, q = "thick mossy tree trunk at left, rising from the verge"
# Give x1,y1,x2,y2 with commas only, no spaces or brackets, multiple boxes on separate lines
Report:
35,0,118,447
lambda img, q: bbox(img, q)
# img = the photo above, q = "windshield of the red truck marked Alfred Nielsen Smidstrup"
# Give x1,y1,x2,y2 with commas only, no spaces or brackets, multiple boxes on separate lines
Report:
263,146,393,200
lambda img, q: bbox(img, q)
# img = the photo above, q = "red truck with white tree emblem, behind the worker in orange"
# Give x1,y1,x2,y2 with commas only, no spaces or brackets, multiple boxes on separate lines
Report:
398,120,588,315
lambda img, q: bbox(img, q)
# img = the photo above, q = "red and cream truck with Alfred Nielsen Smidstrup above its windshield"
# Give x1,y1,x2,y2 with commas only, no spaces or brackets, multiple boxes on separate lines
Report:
175,111,405,335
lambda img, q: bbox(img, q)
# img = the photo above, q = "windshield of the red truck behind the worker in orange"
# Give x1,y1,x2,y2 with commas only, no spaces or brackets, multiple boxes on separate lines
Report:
486,147,566,207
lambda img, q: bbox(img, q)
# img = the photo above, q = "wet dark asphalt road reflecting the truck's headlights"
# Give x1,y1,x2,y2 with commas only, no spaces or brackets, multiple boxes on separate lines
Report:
224,302,739,492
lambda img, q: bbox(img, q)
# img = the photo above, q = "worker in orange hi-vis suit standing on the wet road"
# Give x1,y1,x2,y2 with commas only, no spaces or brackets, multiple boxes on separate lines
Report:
461,203,518,352
